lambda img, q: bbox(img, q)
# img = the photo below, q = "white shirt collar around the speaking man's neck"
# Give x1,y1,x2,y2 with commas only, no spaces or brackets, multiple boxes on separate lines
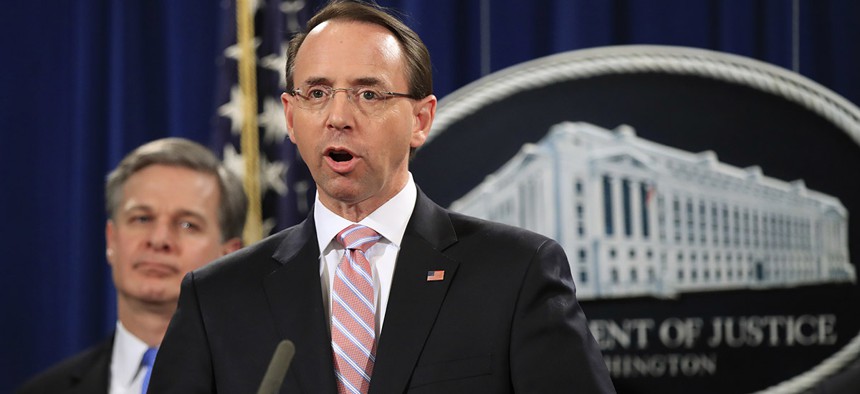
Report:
314,173,418,254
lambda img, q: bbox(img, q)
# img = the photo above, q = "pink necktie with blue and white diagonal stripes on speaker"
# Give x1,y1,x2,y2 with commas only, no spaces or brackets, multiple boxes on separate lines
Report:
331,224,381,394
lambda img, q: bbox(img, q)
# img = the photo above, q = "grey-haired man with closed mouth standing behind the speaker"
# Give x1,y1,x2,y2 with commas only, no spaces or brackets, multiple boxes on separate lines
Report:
19,138,247,394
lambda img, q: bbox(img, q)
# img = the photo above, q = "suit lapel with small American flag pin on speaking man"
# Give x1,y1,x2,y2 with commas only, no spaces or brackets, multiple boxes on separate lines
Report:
370,190,459,393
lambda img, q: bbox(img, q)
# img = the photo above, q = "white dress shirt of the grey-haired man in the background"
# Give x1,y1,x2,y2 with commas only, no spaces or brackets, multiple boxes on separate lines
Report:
108,320,155,394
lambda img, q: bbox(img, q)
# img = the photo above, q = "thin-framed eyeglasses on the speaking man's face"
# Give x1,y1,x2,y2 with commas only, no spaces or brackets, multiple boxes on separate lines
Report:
287,85,412,115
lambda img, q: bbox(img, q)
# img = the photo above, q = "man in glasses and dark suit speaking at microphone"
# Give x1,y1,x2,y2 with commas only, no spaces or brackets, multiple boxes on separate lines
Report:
150,2,614,394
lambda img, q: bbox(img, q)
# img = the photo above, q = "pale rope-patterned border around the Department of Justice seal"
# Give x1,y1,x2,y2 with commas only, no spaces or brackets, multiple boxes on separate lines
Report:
434,45,860,394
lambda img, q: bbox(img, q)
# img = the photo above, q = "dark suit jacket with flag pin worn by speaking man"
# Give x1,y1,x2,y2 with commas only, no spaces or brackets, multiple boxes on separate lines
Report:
149,191,614,394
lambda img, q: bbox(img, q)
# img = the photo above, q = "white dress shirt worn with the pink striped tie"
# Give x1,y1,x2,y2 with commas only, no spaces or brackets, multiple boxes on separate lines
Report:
314,173,418,337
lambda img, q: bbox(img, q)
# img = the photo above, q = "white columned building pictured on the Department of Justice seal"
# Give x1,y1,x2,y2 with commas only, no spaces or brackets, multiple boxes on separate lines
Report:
451,122,856,299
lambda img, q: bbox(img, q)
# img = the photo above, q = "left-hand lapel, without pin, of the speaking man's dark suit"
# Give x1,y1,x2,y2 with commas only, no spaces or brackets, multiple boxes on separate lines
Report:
263,219,336,393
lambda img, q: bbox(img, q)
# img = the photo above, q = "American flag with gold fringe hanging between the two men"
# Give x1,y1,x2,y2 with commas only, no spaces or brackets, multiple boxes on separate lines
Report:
212,0,317,243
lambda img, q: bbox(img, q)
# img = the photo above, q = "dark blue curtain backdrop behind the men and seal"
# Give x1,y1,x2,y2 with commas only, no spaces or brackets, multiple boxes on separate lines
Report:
0,0,860,392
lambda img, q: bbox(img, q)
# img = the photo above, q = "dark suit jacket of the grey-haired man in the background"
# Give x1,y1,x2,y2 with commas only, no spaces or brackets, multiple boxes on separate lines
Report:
16,336,113,394
